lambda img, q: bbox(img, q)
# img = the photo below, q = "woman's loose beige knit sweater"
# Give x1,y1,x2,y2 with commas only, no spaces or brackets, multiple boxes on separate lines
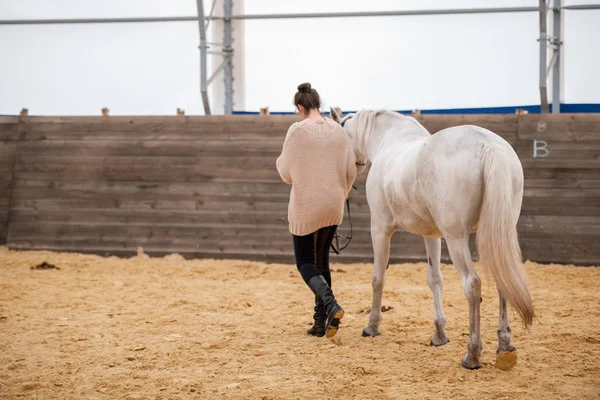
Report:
277,118,356,236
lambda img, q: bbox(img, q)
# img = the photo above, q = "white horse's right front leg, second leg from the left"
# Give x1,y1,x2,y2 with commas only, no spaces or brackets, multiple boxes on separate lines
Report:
425,238,449,347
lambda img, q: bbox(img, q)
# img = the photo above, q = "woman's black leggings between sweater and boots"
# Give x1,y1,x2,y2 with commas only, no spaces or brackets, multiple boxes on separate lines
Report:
292,225,336,287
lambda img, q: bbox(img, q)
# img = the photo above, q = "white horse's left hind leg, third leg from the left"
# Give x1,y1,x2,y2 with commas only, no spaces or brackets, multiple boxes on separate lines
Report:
446,235,483,369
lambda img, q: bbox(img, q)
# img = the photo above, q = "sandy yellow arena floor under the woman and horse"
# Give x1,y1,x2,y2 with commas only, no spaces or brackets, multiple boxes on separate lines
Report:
0,247,600,400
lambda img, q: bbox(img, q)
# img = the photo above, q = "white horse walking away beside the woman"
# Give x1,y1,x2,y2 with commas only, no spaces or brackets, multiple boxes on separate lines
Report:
331,109,534,369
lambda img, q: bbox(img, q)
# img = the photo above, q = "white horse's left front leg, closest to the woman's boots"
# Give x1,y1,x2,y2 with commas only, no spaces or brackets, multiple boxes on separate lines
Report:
362,227,392,336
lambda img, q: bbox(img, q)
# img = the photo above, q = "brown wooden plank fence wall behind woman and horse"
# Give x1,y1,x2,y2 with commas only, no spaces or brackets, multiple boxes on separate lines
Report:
0,114,600,264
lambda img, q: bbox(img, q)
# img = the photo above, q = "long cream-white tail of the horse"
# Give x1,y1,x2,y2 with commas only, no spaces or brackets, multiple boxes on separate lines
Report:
477,145,534,327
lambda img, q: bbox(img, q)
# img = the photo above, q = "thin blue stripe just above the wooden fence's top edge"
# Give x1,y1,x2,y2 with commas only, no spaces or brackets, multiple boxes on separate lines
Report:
233,104,600,115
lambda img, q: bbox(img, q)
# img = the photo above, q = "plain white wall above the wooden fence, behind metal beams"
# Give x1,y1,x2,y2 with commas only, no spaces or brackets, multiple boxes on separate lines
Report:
0,0,600,115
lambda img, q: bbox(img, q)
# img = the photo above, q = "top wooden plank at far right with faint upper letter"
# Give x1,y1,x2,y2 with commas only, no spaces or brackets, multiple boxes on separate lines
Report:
518,114,600,141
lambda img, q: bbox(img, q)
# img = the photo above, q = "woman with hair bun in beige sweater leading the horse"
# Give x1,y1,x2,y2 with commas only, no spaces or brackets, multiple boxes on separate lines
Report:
277,83,356,338
